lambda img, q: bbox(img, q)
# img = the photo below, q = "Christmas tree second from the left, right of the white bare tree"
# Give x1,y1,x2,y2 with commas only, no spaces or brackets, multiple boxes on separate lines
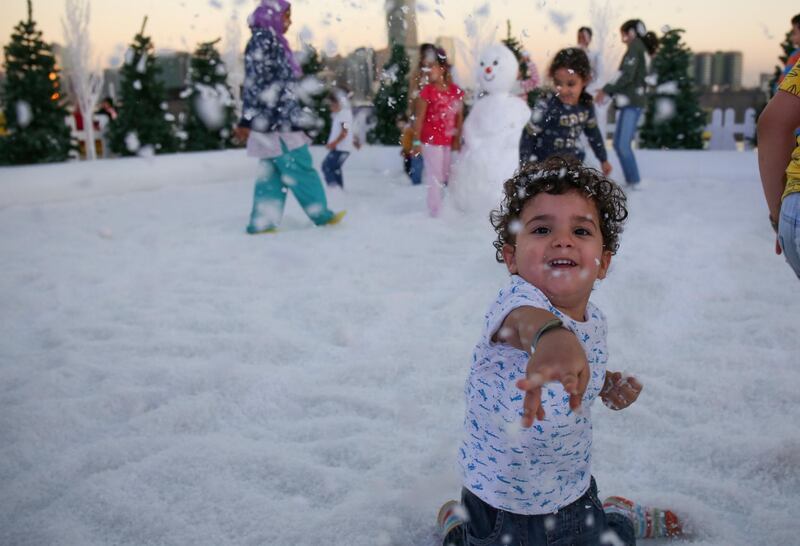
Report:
109,17,177,155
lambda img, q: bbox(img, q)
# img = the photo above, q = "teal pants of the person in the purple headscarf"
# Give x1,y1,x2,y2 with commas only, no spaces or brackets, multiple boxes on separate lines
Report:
247,141,333,233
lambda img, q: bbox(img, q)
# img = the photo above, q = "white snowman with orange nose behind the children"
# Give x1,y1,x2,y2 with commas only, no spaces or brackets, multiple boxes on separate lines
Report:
449,44,531,216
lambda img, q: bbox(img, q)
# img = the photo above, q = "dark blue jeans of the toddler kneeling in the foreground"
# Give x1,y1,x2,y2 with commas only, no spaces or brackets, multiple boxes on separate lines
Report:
450,478,636,546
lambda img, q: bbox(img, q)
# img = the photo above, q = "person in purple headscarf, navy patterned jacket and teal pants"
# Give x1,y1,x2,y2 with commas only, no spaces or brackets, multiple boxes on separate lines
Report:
236,0,344,234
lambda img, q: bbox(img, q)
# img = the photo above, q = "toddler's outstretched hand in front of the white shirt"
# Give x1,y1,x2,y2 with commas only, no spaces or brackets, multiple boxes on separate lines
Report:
517,330,591,428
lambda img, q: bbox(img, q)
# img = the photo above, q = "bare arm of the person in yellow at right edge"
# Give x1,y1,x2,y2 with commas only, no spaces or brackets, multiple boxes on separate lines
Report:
758,90,800,221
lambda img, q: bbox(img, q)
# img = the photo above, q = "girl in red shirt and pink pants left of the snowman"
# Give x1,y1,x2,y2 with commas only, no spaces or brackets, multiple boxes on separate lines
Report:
413,48,464,217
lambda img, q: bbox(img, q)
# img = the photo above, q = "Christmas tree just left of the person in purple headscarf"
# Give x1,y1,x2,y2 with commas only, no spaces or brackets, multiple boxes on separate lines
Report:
181,39,236,151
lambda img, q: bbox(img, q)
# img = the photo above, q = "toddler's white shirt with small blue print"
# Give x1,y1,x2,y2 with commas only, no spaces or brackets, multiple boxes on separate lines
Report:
459,275,608,515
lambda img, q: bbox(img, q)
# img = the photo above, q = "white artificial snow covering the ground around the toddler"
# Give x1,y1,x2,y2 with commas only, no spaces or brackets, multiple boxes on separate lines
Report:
0,148,800,546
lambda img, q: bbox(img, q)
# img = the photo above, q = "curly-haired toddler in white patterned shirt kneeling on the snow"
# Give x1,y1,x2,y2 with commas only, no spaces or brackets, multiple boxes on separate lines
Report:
439,156,680,546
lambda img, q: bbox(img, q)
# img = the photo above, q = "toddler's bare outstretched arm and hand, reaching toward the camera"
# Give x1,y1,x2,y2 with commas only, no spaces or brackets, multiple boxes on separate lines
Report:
494,307,590,427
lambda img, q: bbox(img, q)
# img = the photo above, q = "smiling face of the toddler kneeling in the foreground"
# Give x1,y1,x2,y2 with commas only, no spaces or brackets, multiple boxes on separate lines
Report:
503,191,611,321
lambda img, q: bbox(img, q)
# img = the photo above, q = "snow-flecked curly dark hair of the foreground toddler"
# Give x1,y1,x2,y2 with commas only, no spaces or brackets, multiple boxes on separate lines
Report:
490,155,628,263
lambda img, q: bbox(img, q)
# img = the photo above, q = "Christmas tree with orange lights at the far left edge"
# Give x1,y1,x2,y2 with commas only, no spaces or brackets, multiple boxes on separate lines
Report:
0,0,73,165
